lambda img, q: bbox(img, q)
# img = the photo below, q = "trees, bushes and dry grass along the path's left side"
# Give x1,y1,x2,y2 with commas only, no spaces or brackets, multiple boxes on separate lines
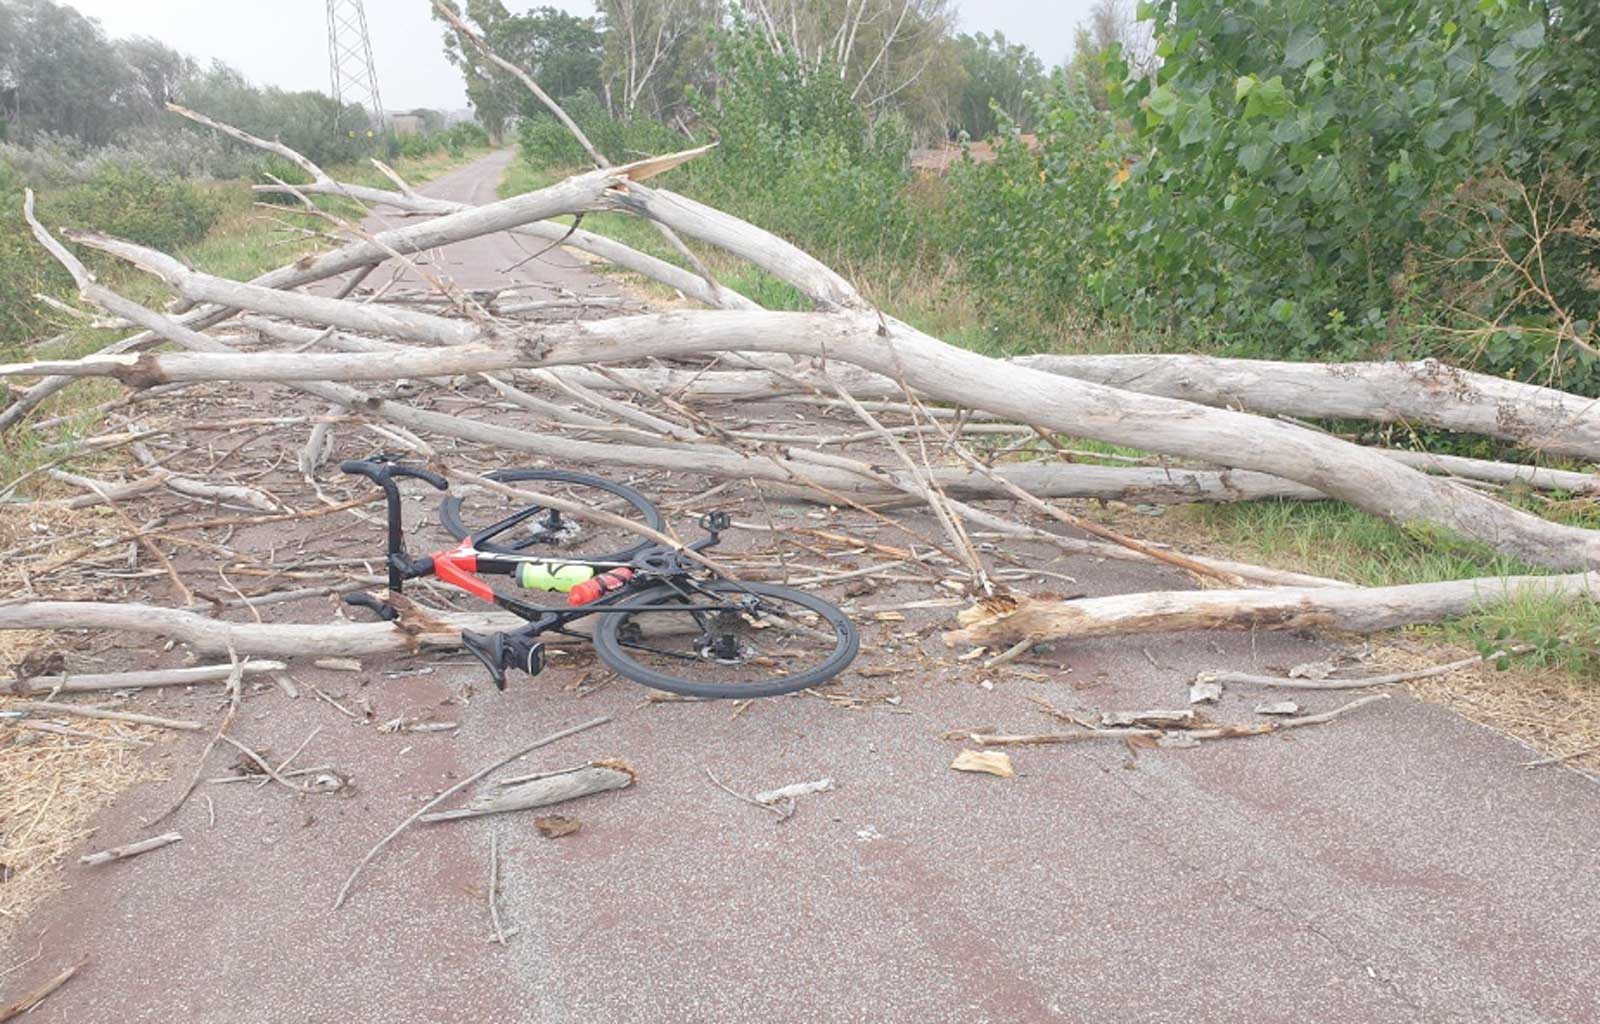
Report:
0,0,488,490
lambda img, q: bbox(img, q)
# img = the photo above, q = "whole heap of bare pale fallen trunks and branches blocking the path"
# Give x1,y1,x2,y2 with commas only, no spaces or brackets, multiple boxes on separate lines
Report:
0,12,1600,668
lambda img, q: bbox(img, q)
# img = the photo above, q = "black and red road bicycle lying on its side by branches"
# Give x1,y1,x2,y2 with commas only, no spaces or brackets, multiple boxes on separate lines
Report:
339,456,861,699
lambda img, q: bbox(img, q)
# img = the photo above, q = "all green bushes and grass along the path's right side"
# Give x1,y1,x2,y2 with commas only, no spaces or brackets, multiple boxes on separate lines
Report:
483,0,1600,674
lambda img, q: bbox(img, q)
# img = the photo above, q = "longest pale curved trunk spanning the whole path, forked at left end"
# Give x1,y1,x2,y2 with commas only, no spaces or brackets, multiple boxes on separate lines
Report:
18,270,1600,568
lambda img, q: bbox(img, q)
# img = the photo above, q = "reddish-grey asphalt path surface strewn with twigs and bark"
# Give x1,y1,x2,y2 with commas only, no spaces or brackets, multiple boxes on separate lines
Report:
0,157,1600,1024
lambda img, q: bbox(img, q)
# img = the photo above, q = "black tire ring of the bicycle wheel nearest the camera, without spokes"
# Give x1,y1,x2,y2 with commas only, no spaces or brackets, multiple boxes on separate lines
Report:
594,579,861,699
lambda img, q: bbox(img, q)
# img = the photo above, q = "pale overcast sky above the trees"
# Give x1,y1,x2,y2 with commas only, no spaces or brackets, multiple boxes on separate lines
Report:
67,0,1090,110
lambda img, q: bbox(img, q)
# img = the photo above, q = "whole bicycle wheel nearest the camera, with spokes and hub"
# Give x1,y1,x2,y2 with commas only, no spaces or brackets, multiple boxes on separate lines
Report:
594,579,861,699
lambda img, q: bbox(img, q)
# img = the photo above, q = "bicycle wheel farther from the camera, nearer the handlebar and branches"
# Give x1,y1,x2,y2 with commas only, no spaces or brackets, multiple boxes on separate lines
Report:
438,469,662,562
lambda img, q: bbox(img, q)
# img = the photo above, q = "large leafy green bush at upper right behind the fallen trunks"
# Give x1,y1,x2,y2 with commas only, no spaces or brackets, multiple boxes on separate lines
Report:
949,0,1600,392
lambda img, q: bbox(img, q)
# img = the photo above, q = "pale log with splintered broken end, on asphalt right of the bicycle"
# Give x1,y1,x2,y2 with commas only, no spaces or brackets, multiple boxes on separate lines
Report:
944,573,1600,646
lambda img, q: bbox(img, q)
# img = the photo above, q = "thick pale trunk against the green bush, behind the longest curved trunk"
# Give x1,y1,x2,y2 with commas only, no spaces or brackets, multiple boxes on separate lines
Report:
1013,355,1600,461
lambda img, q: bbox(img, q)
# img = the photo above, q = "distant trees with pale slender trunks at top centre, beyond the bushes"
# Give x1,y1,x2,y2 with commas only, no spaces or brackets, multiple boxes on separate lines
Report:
445,0,1088,142
